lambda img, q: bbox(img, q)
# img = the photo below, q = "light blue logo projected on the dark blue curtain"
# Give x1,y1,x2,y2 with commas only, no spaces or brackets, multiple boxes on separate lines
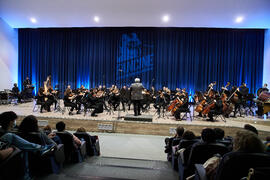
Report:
116,33,154,85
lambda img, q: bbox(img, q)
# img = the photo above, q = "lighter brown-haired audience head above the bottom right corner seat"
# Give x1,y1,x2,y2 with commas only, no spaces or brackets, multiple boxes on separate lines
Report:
233,130,265,153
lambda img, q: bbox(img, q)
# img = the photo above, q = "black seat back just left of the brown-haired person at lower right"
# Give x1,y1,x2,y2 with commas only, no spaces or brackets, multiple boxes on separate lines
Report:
187,143,229,167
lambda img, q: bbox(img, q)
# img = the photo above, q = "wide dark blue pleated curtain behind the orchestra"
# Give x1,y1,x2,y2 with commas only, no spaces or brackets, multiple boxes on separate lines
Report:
18,27,264,93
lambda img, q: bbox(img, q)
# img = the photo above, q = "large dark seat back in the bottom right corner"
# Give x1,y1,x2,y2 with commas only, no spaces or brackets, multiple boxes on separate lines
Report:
216,152,270,180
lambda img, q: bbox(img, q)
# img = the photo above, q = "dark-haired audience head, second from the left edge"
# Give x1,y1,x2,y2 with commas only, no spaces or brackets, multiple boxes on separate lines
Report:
19,115,38,132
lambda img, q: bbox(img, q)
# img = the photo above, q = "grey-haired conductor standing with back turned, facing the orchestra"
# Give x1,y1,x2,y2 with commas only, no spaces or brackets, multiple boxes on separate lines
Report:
130,78,144,116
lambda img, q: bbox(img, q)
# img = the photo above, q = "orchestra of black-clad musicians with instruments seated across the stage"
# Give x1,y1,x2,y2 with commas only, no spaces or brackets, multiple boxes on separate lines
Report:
5,75,270,121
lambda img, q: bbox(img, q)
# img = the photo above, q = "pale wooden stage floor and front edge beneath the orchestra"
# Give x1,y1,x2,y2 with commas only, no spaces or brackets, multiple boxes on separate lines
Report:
0,102,270,139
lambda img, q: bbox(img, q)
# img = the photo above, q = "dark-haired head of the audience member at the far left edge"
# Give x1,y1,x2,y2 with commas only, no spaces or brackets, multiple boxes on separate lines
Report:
0,111,18,130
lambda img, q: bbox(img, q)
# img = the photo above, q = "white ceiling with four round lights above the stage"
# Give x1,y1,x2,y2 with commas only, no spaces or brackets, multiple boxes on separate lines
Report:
0,0,270,28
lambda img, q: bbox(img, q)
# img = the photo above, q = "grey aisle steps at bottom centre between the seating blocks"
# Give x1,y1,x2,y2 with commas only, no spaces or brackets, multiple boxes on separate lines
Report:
37,156,178,180
